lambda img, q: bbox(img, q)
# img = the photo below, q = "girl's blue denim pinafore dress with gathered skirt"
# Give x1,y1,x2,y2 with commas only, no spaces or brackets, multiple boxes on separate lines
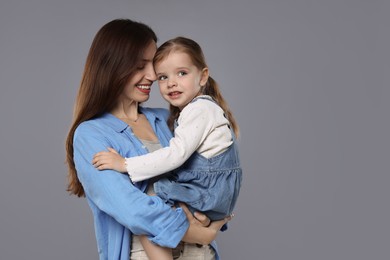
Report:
154,98,242,220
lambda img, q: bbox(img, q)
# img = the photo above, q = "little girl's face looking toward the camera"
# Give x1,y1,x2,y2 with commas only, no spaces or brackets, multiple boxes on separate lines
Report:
155,51,208,110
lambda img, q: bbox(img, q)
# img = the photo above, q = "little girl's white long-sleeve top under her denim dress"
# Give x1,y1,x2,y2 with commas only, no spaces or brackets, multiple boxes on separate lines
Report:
126,95,233,182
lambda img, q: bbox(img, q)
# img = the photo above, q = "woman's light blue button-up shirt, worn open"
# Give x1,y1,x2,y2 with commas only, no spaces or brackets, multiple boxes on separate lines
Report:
73,107,219,260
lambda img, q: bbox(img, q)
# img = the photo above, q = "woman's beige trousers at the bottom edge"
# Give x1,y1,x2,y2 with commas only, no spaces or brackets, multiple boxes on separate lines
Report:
130,236,215,260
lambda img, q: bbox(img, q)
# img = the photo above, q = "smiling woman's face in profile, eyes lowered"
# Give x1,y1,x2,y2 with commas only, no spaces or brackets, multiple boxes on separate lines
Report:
120,41,157,102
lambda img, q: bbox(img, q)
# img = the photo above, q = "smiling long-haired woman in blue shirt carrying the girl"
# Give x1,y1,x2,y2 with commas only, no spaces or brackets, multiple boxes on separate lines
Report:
66,19,228,260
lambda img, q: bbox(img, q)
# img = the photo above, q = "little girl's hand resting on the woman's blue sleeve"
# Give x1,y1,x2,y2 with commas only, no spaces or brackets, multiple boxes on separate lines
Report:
92,147,127,173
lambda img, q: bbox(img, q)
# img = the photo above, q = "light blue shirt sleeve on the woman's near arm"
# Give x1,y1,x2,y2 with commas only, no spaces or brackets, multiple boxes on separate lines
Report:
73,126,189,247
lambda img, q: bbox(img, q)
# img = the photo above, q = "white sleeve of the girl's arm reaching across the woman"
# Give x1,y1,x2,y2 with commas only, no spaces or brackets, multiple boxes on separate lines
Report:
126,101,215,182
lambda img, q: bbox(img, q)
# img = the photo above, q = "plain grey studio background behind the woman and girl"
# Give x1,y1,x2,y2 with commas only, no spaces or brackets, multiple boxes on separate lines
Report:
0,0,390,260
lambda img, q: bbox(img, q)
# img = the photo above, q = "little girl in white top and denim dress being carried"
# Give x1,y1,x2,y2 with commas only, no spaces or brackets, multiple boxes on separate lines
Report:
93,37,242,259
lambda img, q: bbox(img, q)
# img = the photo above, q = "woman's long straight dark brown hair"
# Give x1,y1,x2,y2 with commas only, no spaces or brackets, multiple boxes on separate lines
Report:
65,19,157,197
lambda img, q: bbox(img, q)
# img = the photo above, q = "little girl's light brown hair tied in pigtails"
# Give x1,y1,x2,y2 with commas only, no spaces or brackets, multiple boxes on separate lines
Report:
153,37,239,136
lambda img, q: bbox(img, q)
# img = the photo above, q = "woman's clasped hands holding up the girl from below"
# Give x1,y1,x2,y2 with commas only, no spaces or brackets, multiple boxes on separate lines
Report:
180,203,233,245
